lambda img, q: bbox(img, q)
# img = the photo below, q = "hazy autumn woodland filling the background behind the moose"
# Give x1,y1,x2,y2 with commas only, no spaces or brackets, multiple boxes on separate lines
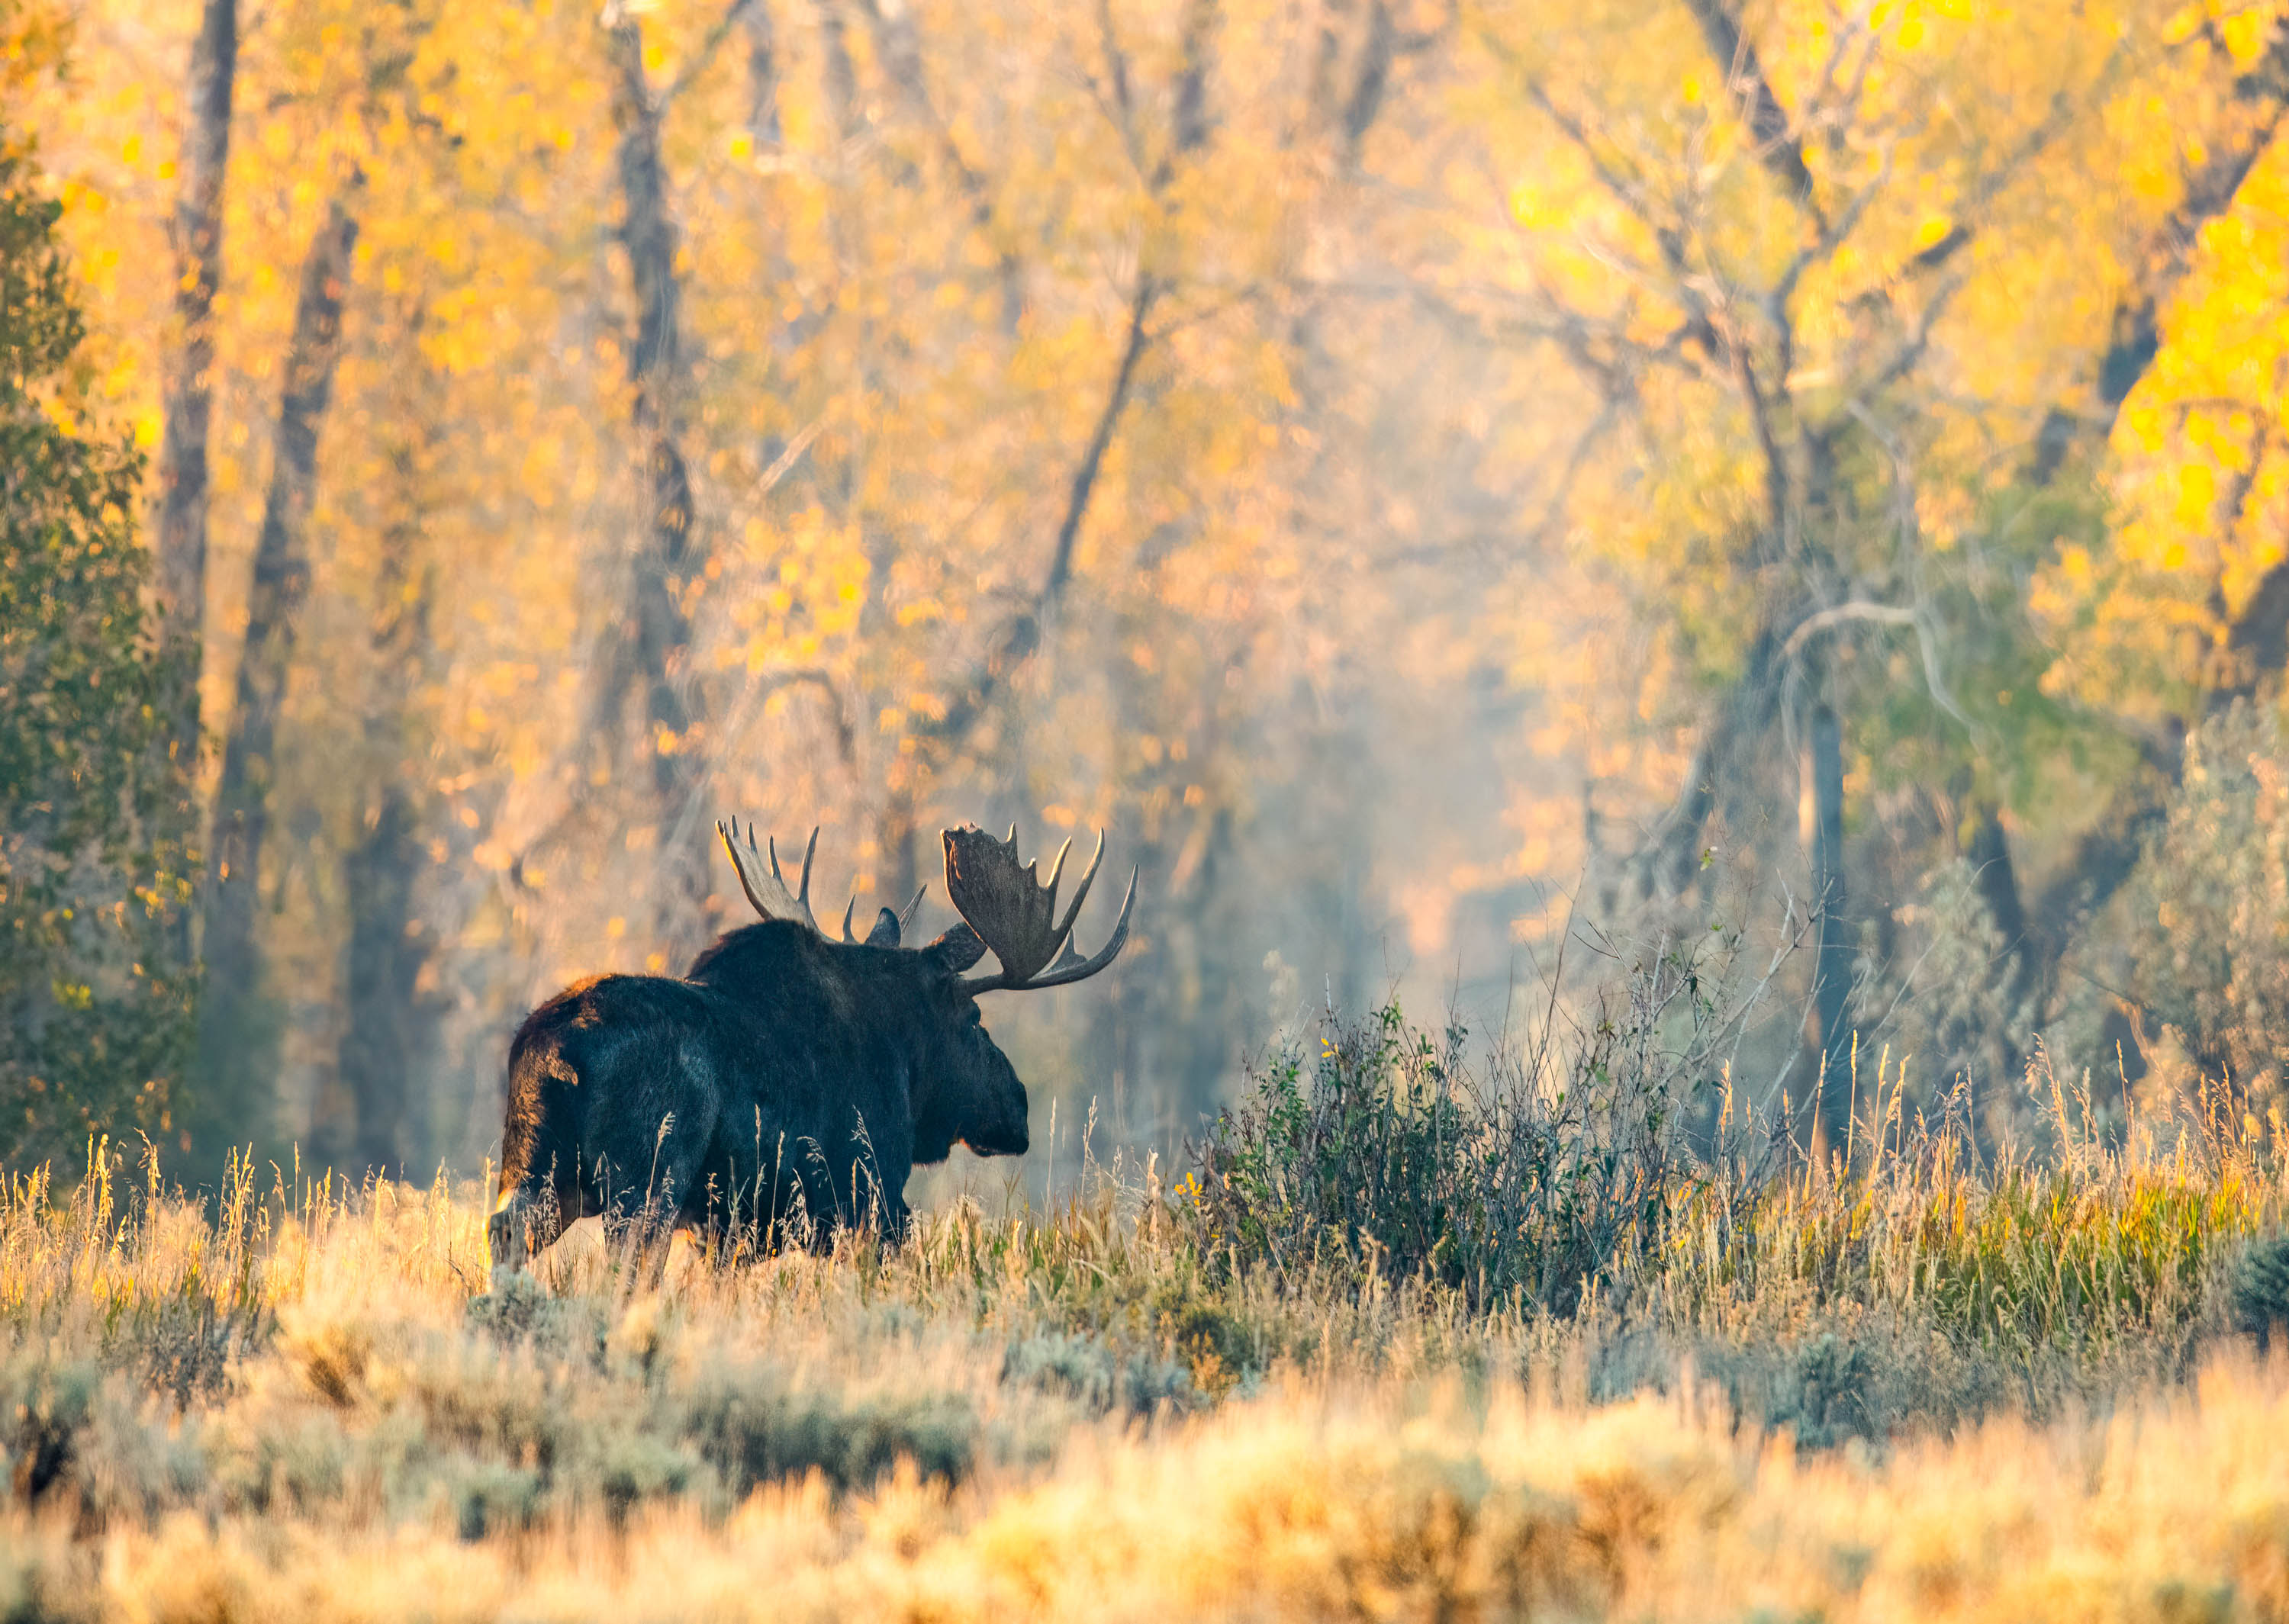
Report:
7,0,2289,1171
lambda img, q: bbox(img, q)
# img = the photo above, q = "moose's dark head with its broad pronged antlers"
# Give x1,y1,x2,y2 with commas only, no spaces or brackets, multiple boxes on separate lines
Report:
716,818,1138,1162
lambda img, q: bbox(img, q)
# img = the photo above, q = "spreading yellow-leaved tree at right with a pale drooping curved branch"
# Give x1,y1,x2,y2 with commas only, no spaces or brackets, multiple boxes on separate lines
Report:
1426,0,2280,1139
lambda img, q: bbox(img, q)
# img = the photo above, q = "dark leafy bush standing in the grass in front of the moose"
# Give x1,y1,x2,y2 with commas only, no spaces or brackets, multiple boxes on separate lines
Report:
1183,942,1744,1313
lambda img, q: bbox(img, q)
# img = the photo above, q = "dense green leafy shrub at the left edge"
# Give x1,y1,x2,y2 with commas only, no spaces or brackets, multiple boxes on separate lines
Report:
0,135,195,1166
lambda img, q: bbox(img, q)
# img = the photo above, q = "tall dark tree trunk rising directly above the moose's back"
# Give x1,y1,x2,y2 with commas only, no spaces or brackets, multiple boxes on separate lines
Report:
607,21,707,949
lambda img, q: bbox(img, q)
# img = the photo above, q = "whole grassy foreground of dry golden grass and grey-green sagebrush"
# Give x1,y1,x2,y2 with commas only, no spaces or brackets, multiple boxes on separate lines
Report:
0,1139,2289,1619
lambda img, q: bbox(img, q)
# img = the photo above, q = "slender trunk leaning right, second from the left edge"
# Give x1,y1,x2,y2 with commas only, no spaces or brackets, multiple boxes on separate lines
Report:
199,188,357,1134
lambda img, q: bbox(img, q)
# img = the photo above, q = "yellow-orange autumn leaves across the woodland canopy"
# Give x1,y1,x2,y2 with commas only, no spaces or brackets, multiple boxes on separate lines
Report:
9,0,2289,1043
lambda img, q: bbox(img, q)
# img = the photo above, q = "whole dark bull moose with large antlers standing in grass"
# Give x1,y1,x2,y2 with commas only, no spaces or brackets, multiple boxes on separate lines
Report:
488,818,1138,1269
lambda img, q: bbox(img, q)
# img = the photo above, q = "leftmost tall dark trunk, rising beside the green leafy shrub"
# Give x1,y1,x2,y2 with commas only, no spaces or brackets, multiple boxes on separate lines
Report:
158,0,238,760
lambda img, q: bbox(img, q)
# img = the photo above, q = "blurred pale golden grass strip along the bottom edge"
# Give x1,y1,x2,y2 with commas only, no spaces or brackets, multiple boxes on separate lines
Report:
7,1361,2289,1622
